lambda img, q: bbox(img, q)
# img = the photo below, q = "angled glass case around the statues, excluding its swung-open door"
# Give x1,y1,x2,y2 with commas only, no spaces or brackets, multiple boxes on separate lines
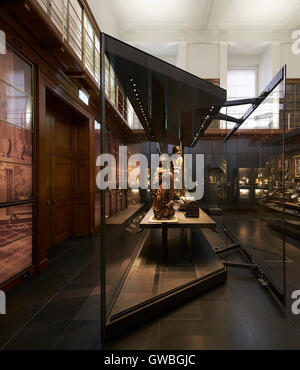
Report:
98,34,227,340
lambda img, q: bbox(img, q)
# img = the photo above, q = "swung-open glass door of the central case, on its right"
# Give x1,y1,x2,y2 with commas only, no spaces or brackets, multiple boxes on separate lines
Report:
224,67,288,303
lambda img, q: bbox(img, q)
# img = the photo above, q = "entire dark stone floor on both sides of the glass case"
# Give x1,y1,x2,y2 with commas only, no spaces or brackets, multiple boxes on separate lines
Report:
0,214,300,350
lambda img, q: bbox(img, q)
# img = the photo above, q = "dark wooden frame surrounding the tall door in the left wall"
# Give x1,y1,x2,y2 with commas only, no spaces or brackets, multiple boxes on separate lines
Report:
33,70,95,271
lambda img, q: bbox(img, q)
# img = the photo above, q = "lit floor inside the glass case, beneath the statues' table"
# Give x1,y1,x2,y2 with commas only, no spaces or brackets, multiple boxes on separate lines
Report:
112,229,224,315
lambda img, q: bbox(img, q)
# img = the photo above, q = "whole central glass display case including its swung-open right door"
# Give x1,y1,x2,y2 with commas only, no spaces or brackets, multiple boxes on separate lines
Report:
99,34,292,340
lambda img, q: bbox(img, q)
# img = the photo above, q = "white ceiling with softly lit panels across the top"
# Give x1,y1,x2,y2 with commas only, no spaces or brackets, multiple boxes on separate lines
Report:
109,0,300,32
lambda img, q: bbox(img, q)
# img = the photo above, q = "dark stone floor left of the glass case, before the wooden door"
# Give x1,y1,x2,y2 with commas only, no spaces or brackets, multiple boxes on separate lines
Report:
0,238,101,350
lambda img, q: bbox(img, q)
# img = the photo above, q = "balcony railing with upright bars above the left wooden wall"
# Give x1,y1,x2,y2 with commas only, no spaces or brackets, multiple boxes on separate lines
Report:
37,0,143,129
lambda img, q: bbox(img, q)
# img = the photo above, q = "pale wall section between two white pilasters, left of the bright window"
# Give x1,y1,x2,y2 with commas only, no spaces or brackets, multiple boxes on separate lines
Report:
187,43,220,78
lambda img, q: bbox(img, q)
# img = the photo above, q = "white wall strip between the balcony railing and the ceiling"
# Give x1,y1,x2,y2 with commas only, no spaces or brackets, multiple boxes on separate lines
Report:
88,0,120,38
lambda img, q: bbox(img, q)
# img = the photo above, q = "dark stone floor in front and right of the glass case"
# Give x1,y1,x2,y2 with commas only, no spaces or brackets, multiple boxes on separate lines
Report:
106,262,300,350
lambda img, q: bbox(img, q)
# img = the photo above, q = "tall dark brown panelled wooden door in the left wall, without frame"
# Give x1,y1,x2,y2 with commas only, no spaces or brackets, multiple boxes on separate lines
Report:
45,94,90,246
